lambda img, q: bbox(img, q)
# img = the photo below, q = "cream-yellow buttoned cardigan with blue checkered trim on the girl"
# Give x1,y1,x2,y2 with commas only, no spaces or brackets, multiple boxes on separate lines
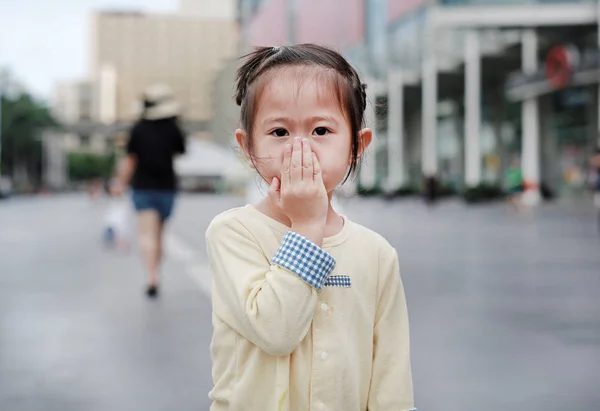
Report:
206,205,414,411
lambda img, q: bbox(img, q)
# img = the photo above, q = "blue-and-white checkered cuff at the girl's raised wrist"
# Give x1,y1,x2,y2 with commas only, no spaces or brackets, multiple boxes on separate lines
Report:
271,231,335,291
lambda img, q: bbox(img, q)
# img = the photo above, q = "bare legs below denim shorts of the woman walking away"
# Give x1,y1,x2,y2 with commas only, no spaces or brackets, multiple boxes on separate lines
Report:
138,210,162,286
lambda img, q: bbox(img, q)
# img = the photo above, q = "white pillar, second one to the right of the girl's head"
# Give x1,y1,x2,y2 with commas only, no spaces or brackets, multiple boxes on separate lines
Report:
386,71,405,191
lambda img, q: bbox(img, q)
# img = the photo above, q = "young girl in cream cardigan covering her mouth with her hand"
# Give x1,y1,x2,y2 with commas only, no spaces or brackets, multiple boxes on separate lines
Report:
206,44,414,411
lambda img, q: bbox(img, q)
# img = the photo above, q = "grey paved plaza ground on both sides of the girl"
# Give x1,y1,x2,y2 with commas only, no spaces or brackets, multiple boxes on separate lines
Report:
0,195,600,411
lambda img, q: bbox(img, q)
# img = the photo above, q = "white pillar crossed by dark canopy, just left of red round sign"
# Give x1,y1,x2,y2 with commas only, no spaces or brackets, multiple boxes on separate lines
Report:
521,29,540,205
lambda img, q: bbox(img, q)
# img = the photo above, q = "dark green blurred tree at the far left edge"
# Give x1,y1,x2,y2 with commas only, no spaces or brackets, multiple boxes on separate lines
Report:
0,71,58,185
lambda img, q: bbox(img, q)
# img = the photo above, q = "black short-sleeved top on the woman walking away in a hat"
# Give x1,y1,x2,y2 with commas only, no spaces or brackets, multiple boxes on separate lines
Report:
127,118,185,191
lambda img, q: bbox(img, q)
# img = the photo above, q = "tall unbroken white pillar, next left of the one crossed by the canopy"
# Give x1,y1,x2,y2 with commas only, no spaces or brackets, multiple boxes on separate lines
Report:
465,30,481,187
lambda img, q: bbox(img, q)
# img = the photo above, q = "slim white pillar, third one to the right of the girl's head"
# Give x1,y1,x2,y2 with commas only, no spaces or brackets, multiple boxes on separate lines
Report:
421,43,438,176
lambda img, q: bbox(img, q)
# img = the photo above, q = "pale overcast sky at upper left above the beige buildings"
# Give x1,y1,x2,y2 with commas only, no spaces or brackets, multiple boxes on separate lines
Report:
0,0,178,99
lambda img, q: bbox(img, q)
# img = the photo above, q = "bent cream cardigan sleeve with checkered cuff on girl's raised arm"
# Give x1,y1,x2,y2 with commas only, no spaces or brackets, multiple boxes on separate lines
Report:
206,217,335,355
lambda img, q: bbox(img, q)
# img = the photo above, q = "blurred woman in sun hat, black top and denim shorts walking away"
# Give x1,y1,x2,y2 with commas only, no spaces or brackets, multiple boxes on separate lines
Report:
113,84,185,297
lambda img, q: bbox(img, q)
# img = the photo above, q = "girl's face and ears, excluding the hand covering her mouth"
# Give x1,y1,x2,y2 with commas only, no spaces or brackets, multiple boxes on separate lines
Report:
236,67,371,192
